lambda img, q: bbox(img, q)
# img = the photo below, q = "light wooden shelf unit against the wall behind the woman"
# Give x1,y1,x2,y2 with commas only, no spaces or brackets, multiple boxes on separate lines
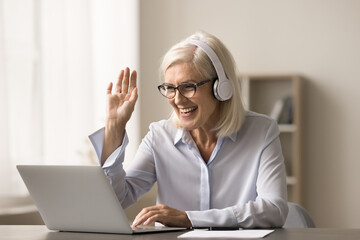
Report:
241,74,303,204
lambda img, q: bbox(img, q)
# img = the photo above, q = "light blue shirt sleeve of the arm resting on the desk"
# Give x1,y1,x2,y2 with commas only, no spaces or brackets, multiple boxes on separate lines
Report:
186,123,288,228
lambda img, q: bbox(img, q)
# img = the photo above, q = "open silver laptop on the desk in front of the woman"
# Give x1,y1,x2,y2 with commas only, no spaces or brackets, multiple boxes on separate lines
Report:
17,165,185,234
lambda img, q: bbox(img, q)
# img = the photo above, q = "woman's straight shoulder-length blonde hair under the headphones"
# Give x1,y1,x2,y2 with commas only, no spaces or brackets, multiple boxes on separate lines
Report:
161,31,245,137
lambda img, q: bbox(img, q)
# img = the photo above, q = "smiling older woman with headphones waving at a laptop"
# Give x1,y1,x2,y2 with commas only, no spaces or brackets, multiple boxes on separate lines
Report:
90,32,288,228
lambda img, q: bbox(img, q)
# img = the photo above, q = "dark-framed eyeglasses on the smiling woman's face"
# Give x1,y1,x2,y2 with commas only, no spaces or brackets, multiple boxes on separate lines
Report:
158,79,215,99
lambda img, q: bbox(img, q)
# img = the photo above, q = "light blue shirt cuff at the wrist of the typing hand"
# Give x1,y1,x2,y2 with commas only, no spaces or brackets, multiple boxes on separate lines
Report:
186,207,238,227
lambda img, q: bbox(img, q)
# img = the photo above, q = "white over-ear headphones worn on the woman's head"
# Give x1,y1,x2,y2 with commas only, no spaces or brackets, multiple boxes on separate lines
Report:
188,40,232,101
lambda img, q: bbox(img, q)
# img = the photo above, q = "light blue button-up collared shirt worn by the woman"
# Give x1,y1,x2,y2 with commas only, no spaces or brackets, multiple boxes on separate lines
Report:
90,112,288,228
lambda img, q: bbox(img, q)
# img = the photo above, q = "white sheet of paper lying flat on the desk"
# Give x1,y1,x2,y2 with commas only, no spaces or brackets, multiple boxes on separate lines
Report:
178,230,274,238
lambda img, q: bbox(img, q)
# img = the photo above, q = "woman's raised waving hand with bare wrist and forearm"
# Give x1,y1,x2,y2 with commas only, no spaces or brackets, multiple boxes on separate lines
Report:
101,68,138,164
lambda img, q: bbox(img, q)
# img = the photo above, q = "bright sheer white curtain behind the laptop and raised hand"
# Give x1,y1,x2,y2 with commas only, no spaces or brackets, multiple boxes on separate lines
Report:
0,0,139,196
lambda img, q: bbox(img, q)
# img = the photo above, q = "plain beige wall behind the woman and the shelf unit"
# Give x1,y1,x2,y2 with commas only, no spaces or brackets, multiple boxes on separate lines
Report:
139,0,360,228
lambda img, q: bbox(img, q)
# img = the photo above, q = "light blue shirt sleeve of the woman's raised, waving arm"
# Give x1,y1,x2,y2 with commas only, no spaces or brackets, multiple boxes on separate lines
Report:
89,128,156,208
